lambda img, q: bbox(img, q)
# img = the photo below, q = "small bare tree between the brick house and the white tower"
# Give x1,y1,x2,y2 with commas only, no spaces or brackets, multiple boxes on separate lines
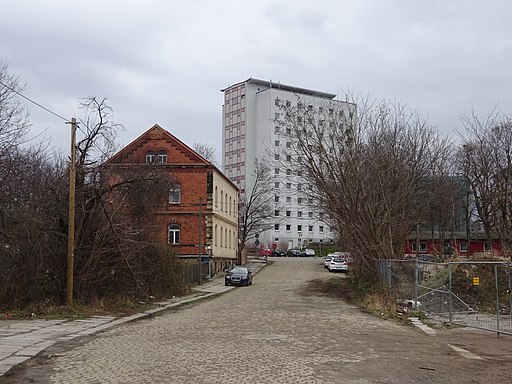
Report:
238,159,274,259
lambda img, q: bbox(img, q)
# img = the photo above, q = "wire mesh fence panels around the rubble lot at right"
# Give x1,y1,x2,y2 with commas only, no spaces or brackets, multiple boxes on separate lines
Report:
378,259,512,334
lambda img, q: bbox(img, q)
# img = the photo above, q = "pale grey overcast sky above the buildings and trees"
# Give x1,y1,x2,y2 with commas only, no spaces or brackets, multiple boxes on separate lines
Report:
0,0,512,160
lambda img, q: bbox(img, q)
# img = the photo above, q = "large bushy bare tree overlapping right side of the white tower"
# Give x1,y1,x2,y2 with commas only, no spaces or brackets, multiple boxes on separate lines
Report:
283,99,448,277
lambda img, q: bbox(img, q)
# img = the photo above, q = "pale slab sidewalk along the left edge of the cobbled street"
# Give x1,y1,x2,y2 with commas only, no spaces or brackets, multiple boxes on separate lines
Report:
0,259,266,376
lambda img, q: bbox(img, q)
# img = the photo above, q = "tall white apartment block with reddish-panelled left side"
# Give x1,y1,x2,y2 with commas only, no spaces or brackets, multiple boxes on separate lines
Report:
221,78,352,249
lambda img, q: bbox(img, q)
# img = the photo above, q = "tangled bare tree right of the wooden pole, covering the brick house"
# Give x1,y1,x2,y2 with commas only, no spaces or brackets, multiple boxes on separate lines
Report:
71,97,181,300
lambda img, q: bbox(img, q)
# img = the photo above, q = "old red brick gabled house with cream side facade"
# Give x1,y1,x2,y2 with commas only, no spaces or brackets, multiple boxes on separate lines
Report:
105,125,238,274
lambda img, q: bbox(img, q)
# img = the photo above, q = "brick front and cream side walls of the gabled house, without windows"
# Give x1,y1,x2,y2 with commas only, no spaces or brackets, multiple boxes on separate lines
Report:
107,125,238,270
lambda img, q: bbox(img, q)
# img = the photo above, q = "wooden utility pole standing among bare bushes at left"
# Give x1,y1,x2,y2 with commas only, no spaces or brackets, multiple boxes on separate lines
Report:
67,117,76,305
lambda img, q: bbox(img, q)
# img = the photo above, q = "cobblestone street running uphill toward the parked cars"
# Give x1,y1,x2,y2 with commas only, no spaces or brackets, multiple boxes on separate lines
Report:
0,258,512,384
